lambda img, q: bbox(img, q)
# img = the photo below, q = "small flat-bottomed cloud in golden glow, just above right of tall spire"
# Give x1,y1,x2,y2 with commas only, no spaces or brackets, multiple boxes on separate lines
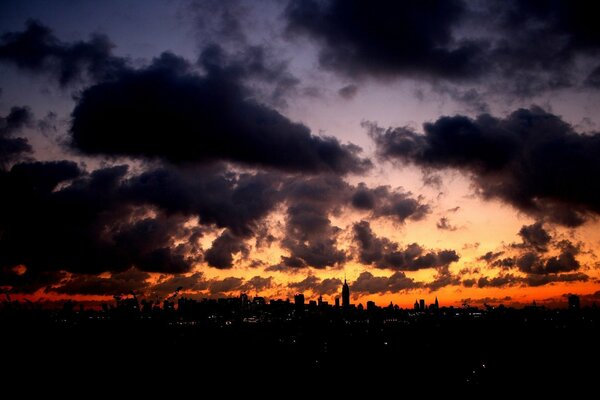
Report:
353,221,459,271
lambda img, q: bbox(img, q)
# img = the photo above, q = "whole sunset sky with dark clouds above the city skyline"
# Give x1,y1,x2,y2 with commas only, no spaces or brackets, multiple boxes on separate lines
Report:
0,0,600,307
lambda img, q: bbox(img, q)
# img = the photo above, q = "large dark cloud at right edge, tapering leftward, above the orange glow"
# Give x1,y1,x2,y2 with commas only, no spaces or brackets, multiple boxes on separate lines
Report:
370,107,600,226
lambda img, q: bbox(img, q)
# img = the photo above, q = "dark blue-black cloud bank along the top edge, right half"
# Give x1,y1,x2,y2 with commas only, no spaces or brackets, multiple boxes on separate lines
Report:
285,0,600,94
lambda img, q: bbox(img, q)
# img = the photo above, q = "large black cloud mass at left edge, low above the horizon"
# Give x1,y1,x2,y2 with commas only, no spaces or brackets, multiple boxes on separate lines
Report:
0,161,199,273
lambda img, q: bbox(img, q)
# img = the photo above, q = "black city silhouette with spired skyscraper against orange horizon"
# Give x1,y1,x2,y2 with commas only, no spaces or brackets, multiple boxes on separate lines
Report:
0,282,600,393
